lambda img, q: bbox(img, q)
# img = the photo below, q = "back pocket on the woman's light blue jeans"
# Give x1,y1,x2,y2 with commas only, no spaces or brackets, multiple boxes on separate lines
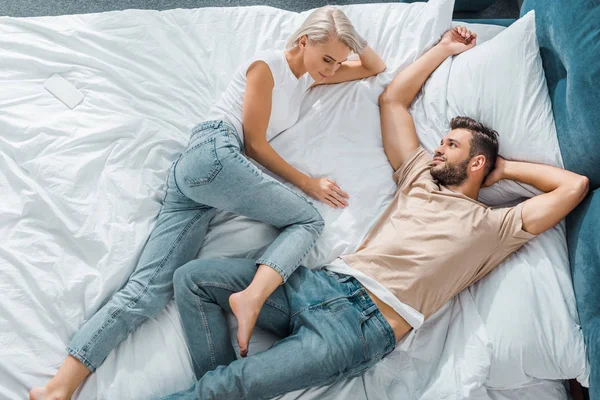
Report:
179,137,223,187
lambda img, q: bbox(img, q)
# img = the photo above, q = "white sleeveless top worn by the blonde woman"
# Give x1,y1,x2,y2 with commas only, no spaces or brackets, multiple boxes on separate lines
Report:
207,50,314,142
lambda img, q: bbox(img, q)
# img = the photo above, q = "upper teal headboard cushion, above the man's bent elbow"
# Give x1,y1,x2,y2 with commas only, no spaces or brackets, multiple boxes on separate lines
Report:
521,0,600,189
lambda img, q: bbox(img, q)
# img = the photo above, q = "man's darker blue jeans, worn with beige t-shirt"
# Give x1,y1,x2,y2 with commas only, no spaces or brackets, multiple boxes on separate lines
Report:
165,259,396,400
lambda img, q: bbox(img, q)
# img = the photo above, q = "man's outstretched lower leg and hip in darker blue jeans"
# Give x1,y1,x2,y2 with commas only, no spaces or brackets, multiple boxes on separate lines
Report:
167,265,395,400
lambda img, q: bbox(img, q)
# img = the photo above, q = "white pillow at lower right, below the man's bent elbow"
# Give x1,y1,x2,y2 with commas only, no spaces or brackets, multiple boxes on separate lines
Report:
468,222,589,389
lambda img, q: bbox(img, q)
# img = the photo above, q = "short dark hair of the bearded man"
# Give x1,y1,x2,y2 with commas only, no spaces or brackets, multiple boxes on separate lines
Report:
450,117,498,179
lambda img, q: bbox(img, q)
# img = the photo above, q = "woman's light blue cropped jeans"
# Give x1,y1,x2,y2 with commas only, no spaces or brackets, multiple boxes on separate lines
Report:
67,121,324,371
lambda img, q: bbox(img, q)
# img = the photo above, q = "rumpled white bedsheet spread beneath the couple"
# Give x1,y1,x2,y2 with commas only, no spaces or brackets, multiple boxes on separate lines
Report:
0,1,577,400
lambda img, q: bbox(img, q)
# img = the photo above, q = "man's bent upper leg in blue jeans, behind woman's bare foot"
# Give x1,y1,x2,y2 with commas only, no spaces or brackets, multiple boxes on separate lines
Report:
173,259,290,379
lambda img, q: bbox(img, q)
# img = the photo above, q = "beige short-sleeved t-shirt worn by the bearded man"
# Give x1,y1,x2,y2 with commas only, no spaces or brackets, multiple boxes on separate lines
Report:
341,147,535,318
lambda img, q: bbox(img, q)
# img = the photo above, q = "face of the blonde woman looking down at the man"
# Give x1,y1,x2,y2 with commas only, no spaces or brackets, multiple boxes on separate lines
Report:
300,36,350,83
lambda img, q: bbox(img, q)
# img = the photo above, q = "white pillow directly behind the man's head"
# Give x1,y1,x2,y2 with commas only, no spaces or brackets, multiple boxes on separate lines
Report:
411,11,563,205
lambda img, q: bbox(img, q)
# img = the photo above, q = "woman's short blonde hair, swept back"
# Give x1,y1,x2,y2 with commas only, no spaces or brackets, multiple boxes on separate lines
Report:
286,6,367,54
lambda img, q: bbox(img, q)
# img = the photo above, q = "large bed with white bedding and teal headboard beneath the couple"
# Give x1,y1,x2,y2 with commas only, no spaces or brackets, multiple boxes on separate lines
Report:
0,0,600,400
